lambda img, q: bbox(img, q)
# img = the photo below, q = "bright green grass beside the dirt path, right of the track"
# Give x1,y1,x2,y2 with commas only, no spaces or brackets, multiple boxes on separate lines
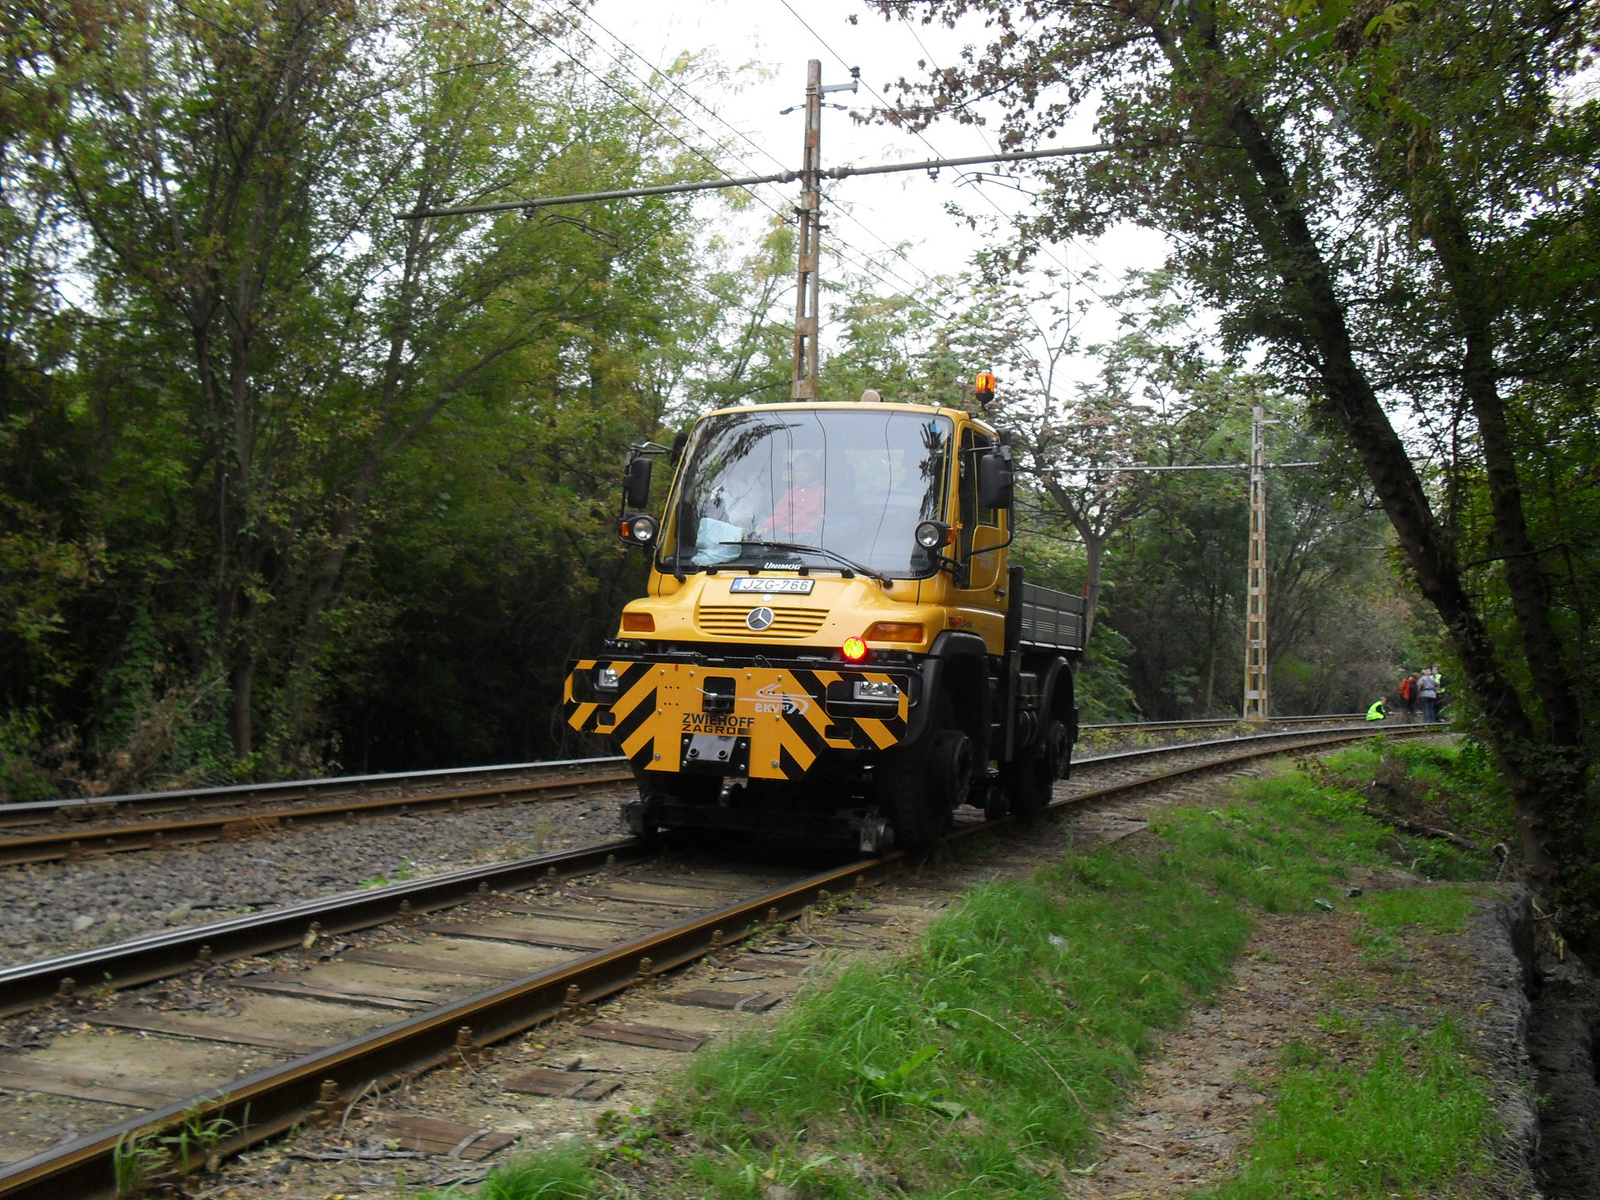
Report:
432,771,1488,1200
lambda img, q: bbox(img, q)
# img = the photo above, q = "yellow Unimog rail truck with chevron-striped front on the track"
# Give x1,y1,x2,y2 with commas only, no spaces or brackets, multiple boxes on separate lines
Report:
563,385,1083,853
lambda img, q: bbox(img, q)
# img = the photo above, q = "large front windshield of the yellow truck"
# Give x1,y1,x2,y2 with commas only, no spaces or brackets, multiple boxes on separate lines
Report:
662,408,950,578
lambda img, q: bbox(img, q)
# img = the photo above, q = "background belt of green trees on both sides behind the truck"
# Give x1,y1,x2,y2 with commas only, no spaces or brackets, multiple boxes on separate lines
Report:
0,0,1497,838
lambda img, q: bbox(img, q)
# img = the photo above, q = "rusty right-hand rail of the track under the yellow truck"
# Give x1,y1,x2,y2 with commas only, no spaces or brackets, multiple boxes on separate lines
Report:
0,726,1438,1200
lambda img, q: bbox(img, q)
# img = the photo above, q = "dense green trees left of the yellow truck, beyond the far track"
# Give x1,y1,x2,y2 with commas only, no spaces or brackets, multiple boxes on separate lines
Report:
0,0,710,792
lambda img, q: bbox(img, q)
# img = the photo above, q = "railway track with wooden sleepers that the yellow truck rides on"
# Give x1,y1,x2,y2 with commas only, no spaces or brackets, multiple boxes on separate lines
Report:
0,726,1435,1197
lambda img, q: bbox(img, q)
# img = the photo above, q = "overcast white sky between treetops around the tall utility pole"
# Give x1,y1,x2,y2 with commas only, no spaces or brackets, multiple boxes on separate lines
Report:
572,0,1162,361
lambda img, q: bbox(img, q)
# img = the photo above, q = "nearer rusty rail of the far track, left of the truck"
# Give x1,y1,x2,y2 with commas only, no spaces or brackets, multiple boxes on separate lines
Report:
0,771,634,866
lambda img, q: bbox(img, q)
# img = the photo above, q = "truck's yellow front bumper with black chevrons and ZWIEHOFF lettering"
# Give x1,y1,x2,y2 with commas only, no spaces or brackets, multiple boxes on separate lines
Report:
562,659,922,781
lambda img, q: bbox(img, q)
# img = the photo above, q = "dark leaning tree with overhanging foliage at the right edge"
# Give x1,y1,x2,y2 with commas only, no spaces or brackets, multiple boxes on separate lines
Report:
880,0,1600,938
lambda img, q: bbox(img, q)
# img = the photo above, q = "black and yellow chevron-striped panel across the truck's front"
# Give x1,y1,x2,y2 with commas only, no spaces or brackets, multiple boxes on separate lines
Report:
562,659,909,779
